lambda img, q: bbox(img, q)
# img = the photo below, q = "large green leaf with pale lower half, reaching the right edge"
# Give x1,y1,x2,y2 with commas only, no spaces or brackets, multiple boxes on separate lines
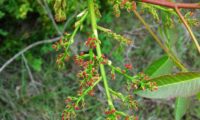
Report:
136,72,200,99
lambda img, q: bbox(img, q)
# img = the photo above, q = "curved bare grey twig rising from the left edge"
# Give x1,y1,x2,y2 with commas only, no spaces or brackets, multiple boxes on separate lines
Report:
0,37,60,73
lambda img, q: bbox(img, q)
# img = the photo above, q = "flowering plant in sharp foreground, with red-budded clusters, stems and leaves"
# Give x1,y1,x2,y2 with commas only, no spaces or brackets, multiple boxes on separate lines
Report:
53,0,200,120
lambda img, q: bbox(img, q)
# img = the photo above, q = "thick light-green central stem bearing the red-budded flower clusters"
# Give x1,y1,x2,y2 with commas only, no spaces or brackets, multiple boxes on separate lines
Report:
88,0,114,109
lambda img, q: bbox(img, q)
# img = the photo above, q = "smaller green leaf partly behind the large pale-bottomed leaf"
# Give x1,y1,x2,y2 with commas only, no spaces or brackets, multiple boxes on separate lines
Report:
144,55,173,78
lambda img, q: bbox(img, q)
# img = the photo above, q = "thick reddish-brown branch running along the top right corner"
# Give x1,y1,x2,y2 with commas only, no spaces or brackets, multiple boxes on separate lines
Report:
141,0,200,9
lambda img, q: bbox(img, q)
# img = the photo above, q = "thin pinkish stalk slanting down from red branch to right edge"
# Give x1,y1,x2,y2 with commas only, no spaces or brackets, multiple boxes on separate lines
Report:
175,7,200,53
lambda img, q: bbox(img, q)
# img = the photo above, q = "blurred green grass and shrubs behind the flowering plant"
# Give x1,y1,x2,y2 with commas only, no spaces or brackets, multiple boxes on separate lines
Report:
0,0,200,120
